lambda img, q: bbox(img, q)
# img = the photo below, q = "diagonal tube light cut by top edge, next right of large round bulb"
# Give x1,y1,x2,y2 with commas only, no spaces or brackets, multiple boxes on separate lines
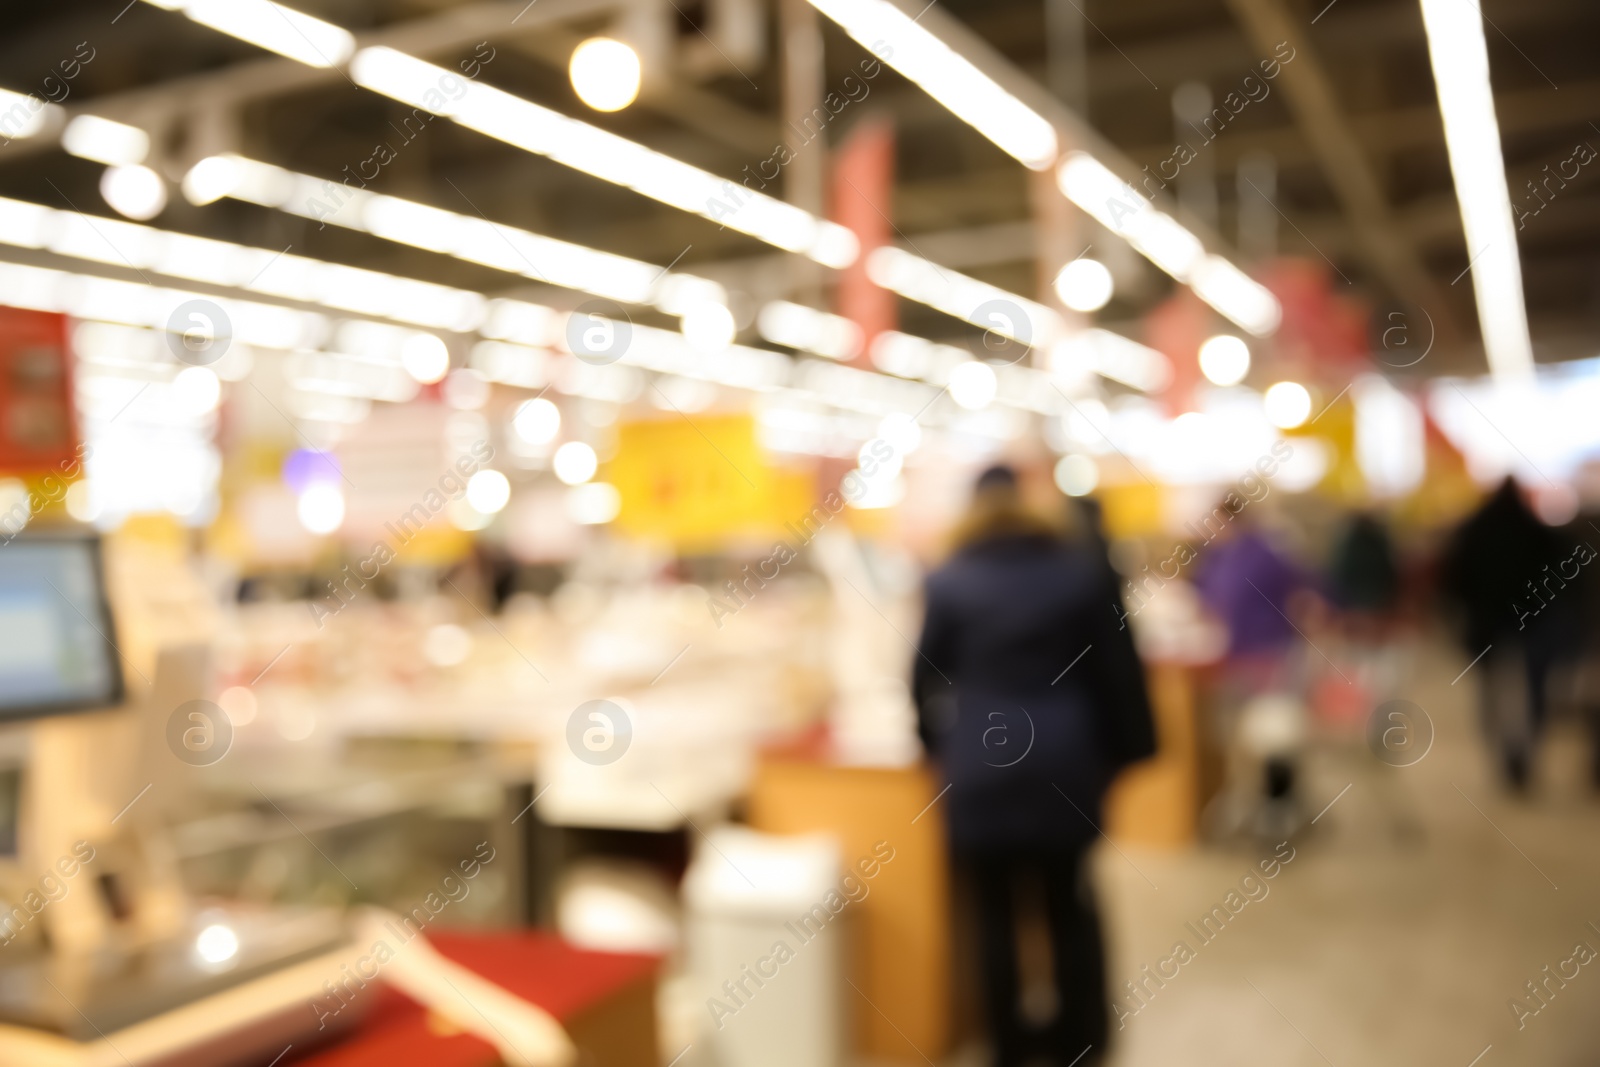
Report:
811,0,1059,170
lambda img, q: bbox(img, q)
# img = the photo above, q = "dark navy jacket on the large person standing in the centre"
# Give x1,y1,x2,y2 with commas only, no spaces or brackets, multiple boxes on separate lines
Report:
912,534,1155,848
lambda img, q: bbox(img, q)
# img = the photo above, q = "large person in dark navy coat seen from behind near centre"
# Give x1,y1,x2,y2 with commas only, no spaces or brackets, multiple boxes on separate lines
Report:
912,467,1155,1067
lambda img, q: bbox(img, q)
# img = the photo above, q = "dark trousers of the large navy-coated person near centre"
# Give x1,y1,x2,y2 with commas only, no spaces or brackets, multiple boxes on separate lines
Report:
957,848,1109,1067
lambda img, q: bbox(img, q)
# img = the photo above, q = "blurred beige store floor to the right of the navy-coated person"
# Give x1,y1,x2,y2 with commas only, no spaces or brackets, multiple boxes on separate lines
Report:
928,633,1600,1067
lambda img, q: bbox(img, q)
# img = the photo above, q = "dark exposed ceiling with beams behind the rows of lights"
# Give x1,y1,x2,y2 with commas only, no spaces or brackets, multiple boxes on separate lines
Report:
0,0,1600,373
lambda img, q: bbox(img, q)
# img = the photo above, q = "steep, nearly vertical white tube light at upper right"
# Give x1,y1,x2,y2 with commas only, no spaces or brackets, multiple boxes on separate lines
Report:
1422,0,1533,379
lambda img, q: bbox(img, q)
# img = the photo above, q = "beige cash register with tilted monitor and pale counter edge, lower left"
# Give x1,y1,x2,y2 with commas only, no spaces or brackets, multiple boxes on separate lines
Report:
0,531,573,1067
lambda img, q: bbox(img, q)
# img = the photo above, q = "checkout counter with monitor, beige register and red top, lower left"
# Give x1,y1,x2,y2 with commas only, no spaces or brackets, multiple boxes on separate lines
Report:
0,533,636,1067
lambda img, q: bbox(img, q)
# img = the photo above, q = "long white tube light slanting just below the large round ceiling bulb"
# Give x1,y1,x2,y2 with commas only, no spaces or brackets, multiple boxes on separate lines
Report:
350,46,861,269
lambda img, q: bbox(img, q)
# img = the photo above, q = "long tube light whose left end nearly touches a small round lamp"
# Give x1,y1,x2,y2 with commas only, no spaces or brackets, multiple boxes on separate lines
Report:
184,155,728,314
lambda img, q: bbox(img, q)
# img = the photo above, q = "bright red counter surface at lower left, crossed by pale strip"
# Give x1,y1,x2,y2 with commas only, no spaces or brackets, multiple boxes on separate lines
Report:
292,931,658,1067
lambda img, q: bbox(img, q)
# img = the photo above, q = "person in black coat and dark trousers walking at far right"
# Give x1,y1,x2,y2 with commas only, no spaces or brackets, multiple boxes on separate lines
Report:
1438,477,1574,792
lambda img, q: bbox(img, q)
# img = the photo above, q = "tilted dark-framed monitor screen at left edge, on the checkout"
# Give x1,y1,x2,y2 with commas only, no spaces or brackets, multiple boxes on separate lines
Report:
0,537,122,718
